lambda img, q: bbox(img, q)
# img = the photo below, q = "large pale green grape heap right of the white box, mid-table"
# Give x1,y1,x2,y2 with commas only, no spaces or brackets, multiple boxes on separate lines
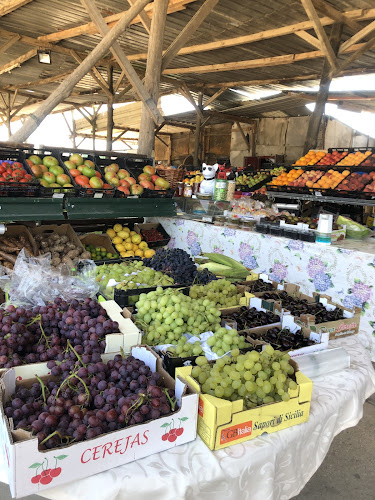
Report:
135,287,221,345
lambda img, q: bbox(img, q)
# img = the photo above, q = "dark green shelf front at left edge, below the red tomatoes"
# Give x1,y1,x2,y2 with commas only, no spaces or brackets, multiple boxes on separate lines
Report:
0,197,64,222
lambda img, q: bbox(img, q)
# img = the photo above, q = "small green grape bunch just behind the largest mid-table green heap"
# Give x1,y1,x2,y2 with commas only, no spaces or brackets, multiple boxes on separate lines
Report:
189,279,242,307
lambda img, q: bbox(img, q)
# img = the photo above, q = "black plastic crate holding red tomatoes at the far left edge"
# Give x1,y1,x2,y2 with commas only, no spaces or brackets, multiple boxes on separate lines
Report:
0,149,40,197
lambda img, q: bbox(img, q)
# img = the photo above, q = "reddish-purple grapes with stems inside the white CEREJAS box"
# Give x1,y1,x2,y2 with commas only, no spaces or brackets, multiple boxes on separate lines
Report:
5,348,176,450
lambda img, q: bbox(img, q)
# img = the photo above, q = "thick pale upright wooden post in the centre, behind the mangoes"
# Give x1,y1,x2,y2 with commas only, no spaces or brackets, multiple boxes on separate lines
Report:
138,0,168,156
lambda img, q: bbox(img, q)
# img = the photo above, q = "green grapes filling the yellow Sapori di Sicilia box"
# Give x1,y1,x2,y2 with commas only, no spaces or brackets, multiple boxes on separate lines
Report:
191,345,298,409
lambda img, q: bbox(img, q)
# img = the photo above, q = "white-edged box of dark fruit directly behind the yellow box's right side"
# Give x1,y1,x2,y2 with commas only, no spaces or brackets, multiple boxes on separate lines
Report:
244,314,329,358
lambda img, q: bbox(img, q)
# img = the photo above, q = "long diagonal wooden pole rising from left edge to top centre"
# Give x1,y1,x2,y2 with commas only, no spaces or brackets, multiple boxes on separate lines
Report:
11,0,154,142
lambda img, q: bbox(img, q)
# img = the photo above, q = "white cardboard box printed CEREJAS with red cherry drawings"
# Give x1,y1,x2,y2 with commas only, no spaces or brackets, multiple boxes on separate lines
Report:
0,346,198,498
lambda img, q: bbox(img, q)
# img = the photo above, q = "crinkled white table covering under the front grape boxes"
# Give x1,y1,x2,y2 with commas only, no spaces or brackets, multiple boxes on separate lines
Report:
0,336,375,500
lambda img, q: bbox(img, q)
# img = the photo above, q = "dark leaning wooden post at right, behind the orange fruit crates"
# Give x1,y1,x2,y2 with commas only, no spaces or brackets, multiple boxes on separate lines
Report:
304,24,342,153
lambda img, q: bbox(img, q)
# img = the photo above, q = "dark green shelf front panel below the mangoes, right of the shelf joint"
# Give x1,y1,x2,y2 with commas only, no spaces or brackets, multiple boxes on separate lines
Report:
65,198,176,220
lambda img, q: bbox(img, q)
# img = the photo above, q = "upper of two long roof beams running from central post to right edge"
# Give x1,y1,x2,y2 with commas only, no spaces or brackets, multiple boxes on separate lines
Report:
122,9,375,61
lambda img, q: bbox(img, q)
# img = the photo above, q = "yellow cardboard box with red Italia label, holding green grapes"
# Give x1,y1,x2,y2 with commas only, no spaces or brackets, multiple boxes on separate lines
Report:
176,361,313,450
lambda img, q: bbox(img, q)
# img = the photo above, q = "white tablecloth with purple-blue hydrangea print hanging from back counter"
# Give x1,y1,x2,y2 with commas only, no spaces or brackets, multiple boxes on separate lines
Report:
151,218,375,360
